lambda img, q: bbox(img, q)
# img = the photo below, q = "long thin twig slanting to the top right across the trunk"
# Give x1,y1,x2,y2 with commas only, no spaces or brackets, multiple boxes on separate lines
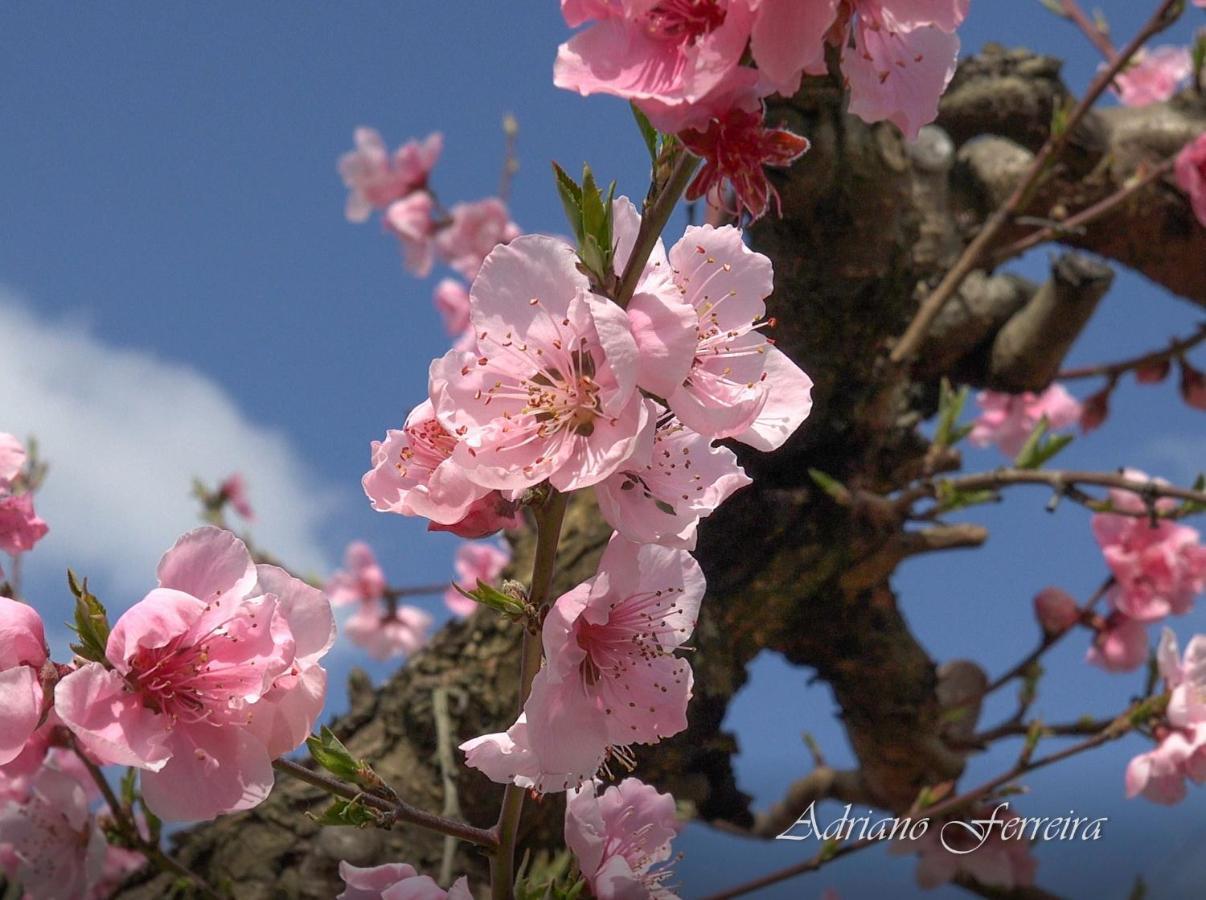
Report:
890,0,1183,366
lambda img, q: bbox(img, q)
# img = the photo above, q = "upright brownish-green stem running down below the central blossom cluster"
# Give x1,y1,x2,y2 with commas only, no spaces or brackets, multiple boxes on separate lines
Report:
490,490,569,900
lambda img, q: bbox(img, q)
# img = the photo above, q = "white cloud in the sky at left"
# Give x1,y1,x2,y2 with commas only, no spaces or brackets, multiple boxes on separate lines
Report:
0,288,335,600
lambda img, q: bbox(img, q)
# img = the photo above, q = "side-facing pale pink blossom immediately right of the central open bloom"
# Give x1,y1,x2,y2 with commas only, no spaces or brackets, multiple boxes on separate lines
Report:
666,226,813,450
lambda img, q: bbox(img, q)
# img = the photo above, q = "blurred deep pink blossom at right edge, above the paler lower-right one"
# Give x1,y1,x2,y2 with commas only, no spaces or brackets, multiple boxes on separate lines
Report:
1091,471,1206,621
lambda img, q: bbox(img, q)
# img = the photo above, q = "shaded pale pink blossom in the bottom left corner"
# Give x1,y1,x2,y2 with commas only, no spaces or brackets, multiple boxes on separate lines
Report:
0,766,106,900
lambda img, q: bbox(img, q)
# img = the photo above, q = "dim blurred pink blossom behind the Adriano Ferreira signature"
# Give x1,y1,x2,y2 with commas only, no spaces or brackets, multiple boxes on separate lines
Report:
894,803,1038,890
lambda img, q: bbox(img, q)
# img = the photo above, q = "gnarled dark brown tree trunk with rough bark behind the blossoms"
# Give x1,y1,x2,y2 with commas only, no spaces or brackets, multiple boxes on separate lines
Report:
121,46,1206,900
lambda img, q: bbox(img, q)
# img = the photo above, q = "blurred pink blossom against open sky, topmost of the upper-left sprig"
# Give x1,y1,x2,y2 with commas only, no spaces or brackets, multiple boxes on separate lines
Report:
339,128,444,222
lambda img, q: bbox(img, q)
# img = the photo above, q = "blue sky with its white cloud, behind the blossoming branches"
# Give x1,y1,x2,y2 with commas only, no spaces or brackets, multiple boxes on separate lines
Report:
0,0,1206,898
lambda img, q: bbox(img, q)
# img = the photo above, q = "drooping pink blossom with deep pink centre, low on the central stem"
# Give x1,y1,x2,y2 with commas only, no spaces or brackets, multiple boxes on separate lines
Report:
461,536,704,793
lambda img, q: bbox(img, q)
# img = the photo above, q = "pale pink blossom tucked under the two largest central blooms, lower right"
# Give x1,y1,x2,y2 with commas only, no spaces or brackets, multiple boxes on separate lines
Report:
595,416,750,550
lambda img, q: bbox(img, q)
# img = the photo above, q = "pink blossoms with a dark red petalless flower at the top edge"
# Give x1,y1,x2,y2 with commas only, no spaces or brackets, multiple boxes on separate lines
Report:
554,0,970,218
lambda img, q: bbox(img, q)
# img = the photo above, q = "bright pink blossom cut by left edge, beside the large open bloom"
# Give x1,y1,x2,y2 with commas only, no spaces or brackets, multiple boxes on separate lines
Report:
0,597,47,765
